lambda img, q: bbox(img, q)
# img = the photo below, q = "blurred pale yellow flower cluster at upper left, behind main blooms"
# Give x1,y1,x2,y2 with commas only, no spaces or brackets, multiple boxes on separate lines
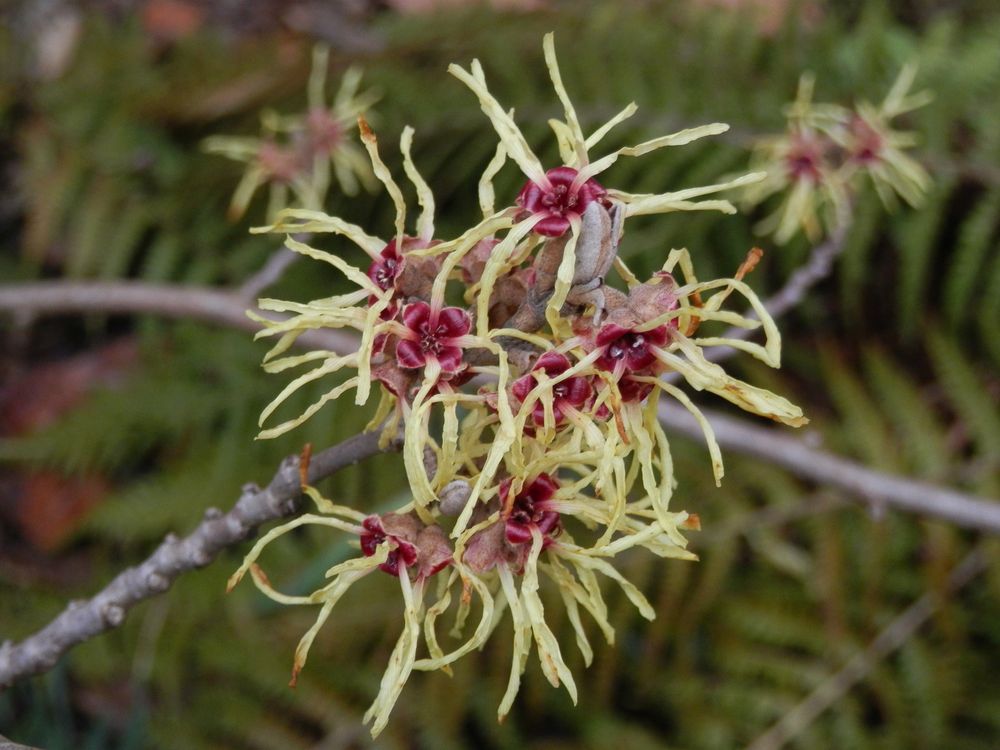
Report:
203,46,378,220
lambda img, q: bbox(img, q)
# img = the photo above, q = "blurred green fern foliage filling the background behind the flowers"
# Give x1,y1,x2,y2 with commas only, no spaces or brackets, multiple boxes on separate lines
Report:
0,0,1000,750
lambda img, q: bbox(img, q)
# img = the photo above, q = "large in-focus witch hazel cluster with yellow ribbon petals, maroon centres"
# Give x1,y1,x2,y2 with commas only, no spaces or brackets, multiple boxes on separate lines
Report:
231,35,806,734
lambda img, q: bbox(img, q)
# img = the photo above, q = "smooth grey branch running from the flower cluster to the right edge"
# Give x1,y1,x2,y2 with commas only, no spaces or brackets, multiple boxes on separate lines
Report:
659,403,1000,534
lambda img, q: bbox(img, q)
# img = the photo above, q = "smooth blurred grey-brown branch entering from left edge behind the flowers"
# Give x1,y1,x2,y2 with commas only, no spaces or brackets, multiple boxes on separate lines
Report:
0,282,357,351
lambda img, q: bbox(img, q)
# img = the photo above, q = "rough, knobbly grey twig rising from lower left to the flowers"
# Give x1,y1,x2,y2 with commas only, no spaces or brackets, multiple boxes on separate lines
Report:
0,431,399,688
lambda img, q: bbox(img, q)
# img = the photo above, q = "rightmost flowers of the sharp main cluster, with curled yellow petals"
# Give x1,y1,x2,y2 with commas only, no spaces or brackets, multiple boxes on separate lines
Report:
511,250,806,543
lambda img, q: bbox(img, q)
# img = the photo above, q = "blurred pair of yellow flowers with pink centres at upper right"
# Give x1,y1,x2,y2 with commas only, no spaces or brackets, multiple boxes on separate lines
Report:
744,65,931,243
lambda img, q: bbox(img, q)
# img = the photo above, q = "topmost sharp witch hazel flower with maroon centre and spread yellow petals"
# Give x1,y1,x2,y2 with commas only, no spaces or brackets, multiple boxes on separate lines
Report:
448,33,763,327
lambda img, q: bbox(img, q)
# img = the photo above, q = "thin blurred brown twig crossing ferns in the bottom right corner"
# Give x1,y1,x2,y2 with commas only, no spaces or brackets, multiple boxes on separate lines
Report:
747,545,987,750
